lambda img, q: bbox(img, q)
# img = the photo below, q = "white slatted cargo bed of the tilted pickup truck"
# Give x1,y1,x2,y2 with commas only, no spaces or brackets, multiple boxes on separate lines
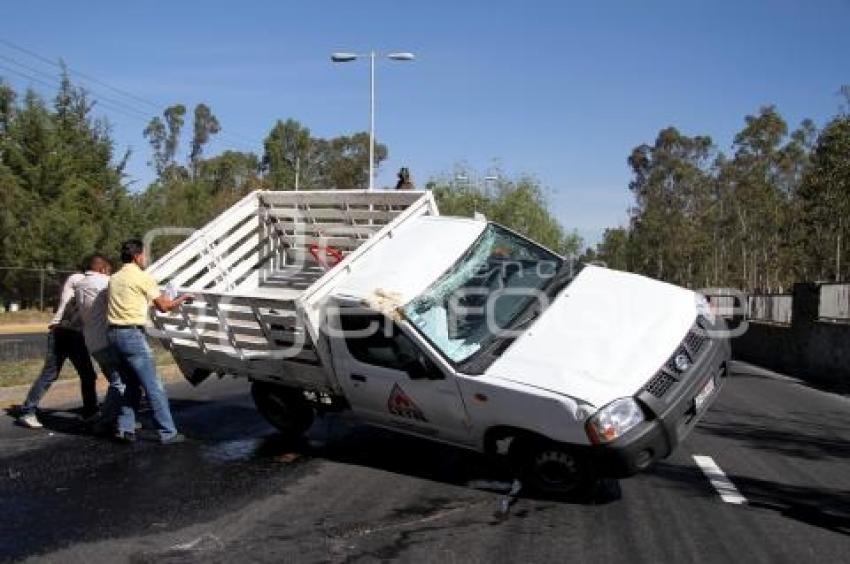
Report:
149,191,436,383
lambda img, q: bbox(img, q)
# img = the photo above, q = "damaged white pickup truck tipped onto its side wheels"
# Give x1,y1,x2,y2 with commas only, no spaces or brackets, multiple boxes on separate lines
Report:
149,191,730,494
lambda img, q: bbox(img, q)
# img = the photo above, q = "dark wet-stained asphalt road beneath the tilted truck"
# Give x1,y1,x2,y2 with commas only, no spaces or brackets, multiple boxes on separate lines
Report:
0,364,850,564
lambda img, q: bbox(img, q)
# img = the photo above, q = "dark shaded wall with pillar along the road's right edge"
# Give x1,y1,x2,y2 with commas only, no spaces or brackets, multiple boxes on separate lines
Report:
732,284,850,389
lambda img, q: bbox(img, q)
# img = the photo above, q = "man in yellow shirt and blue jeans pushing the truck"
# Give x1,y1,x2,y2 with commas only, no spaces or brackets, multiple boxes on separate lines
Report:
106,239,192,444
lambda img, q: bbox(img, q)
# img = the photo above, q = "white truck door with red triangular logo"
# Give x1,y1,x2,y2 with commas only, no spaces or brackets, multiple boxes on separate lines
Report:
330,308,470,442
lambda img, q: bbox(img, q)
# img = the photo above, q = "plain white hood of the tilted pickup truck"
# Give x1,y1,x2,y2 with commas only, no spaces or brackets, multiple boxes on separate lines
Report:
486,266,697,407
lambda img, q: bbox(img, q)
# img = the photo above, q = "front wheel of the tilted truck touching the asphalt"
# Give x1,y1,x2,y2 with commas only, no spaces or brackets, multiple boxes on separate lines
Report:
511,439,595,498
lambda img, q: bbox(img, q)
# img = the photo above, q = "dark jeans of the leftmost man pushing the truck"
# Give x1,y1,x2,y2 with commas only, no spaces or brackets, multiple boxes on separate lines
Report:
21,327,97,415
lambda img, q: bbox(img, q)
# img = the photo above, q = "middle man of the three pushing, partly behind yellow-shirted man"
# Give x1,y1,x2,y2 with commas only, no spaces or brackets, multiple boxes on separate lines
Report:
74,254,129,432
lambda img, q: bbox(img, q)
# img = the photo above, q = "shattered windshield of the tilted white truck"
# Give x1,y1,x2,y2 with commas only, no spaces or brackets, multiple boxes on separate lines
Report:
403,223,563,362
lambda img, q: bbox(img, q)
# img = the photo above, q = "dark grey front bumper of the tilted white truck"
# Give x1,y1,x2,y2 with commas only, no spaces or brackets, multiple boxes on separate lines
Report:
591,326,731,477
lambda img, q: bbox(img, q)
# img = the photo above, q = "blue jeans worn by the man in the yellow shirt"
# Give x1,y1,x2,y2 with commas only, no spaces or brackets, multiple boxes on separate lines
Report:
109,327,177,439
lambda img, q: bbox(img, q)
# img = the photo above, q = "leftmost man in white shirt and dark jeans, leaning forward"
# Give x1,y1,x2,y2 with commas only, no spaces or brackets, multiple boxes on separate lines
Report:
18,258,97,429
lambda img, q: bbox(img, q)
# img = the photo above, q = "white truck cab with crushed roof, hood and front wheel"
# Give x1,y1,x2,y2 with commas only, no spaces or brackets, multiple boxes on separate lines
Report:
318,217,729,490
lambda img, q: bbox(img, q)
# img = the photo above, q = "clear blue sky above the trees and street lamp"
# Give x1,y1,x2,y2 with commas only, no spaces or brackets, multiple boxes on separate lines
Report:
0,0,850,242
